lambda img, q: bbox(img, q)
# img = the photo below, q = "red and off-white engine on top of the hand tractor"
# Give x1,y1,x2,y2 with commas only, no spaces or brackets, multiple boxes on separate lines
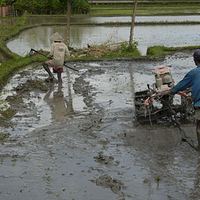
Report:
153,67,174,92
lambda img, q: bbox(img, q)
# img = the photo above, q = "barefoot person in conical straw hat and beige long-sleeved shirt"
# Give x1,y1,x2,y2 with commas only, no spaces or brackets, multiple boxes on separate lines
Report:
43,32,70,82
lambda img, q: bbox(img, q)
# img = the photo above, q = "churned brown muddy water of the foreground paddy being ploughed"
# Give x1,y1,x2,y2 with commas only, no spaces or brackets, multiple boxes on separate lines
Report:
0,52,200,200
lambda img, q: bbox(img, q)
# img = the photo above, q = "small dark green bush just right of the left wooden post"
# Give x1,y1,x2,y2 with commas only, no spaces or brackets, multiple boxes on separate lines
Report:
72,0,90,14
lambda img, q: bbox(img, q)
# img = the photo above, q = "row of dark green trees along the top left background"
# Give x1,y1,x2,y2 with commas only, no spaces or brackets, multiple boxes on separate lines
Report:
0,0,90,15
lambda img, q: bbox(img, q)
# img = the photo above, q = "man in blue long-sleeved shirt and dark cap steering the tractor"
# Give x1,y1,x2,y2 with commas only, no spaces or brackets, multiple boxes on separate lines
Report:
170,49,200,149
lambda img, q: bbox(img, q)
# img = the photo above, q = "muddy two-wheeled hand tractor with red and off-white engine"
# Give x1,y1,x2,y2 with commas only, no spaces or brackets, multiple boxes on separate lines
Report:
135,66,195,124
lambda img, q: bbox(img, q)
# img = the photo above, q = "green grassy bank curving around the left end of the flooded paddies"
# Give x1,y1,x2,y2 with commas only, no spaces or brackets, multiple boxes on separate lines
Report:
0,16,49,88
